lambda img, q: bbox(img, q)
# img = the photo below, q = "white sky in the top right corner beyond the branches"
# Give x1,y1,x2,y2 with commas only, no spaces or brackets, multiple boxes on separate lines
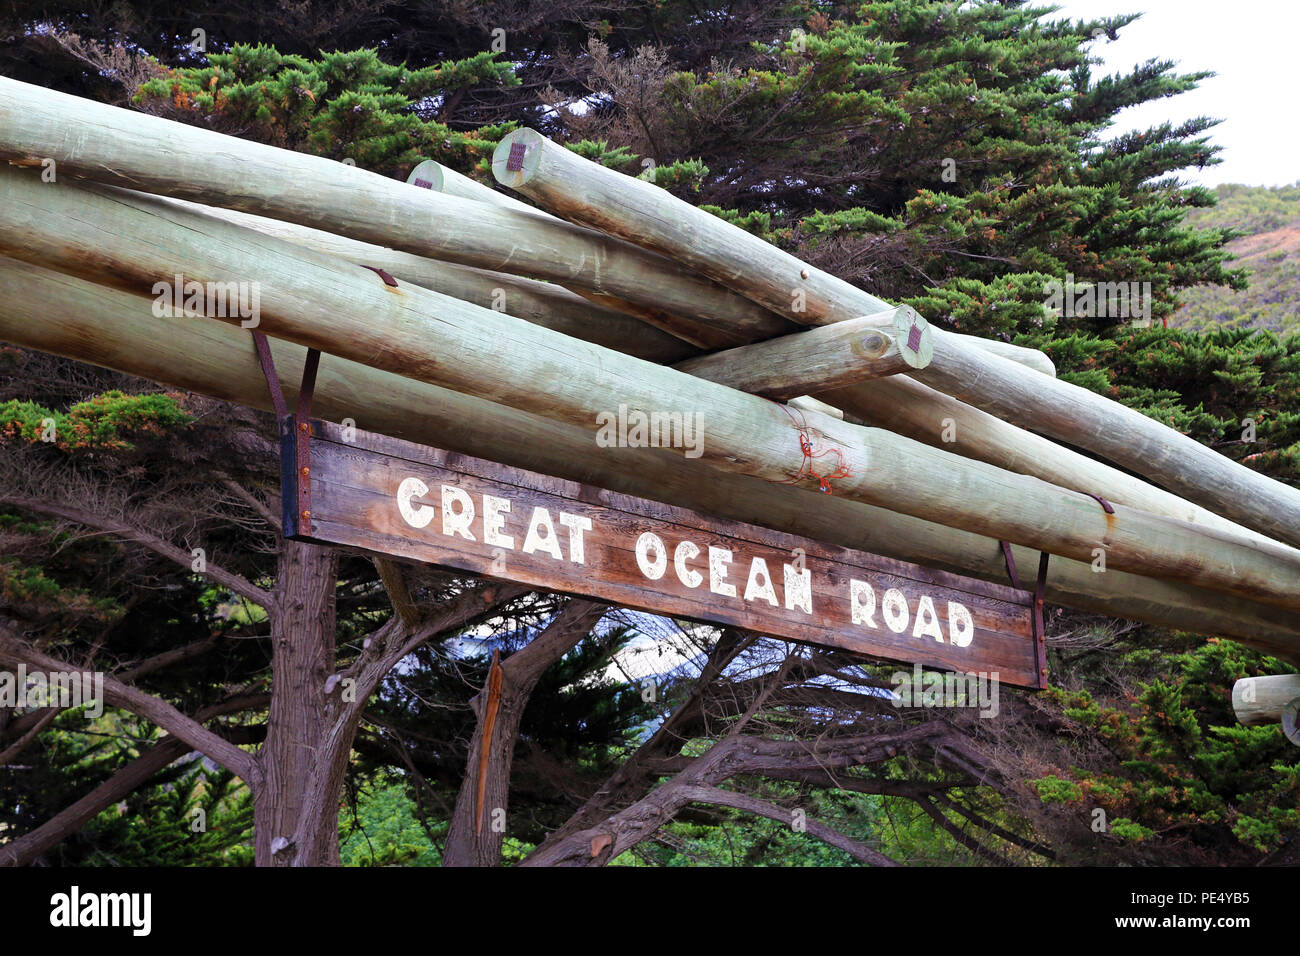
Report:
1045,0,1300,186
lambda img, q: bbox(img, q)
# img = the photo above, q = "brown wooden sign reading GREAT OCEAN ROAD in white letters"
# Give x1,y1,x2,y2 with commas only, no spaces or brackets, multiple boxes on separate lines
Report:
281,416,1047,688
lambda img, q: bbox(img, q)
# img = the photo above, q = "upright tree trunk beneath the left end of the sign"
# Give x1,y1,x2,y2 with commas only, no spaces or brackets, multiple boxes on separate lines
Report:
254,541,339,866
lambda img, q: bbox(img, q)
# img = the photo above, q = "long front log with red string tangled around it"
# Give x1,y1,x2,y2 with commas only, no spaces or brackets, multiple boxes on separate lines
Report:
0,168,1300,610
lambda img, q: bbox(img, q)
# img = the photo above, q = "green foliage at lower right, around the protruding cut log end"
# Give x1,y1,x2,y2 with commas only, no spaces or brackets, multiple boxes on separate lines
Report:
1032,639,1300,864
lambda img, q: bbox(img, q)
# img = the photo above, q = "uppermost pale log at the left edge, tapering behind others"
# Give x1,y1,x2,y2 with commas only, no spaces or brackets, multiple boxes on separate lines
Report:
0,77,790,346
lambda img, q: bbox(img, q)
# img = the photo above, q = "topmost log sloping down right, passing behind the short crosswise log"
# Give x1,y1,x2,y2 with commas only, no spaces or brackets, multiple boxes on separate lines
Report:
493,130,1300,545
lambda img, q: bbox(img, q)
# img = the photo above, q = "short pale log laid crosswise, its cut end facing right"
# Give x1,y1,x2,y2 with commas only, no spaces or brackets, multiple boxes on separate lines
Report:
673,306,930,399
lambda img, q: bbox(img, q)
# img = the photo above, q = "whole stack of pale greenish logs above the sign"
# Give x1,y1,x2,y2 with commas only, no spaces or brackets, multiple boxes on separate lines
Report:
0,78,1300,719
